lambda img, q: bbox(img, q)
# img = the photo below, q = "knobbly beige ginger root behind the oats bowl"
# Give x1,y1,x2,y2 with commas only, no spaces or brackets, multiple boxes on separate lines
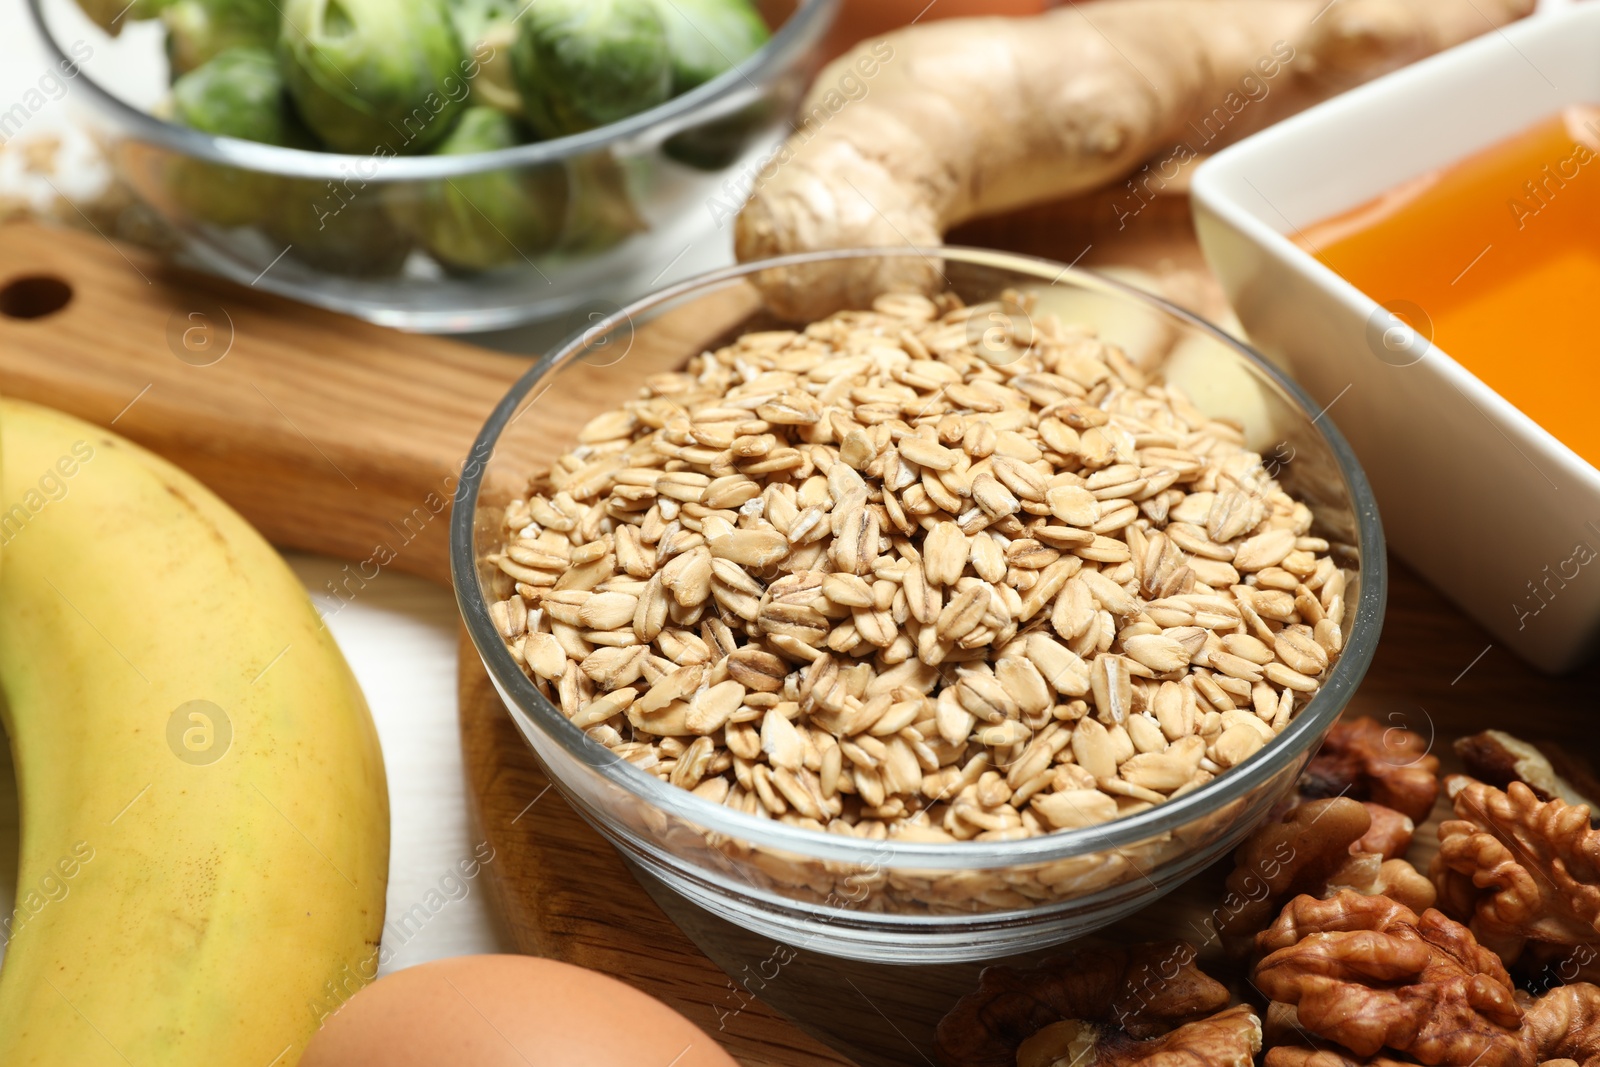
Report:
736,0,1533,320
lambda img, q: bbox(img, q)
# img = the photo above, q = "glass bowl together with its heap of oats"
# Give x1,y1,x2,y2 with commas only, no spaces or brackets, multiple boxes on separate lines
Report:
451,248,1386,963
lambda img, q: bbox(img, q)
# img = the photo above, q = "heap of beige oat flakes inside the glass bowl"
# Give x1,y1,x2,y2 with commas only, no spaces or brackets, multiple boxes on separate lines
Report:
490,294,1347,905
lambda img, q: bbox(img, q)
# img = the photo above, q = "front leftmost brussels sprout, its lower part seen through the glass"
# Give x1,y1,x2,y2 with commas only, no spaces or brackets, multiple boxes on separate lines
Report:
166,48,314,226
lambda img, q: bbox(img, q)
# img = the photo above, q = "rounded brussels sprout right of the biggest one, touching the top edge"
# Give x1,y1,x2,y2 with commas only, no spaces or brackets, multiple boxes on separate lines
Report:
512,0,672,138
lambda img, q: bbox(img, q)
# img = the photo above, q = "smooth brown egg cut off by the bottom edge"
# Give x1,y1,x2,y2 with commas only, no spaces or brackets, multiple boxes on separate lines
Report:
301,957,738,1067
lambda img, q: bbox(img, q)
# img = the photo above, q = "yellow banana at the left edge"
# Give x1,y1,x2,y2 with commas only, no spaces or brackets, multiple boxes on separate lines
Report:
0,402,389,1067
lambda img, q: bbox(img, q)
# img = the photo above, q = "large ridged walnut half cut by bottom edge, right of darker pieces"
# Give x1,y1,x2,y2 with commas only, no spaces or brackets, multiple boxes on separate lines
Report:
1254,893,1536,1067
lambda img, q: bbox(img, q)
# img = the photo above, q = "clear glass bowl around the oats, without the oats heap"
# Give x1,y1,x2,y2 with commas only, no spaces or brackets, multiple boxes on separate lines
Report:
451,248,1386,963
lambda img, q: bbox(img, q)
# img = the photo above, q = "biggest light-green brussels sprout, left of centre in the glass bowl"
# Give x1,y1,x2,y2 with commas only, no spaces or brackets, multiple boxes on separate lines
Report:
278,0,470,155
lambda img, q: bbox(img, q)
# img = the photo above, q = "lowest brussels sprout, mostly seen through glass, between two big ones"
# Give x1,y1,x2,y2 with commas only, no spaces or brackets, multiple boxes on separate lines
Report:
397,107,568,270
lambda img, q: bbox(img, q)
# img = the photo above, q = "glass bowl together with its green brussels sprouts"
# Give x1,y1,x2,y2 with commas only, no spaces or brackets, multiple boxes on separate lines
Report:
27,0,838,333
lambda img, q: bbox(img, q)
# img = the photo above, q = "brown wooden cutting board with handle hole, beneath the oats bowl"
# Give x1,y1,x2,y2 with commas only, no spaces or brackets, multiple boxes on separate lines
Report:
0,217,1600,1067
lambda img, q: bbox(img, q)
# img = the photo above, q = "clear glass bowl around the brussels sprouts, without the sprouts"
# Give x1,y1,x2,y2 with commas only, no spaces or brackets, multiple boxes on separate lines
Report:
27,0,838,333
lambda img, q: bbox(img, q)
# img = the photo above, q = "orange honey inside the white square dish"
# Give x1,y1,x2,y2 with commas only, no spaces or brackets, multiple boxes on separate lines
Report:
1298,107,1600,466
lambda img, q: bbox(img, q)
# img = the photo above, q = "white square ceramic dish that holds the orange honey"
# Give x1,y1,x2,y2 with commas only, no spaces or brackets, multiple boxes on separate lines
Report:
1192,5,1600,672
